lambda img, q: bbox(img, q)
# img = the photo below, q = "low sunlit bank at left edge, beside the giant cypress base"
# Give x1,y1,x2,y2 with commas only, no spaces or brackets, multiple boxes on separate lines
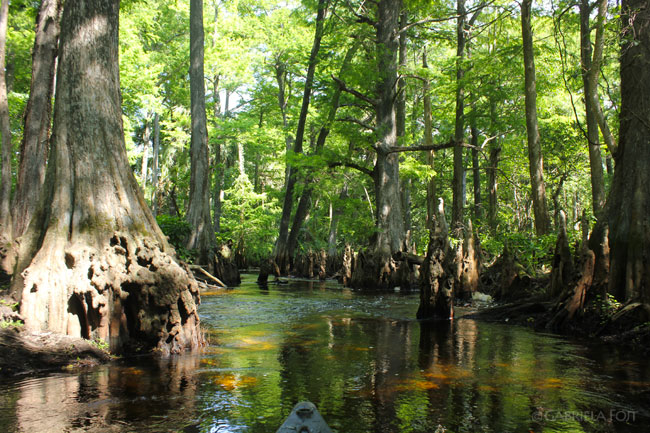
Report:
0,297,111,377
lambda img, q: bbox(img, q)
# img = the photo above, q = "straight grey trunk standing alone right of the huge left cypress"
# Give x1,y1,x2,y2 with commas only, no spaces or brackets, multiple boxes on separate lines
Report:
187,0,216,266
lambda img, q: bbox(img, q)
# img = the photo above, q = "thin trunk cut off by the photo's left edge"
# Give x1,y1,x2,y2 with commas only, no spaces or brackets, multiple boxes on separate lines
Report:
0,0,13,245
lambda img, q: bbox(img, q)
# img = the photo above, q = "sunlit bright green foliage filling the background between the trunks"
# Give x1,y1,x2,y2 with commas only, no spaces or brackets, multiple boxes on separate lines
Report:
7,0,620,272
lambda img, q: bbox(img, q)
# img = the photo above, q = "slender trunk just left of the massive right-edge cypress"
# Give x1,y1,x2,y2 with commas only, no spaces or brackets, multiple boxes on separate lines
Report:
580,0,605,215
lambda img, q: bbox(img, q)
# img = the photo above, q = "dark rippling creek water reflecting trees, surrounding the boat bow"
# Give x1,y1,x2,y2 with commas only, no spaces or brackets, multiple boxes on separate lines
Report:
0,276,650,433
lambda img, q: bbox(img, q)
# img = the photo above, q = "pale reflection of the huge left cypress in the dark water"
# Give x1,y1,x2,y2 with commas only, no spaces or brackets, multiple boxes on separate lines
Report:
0,356,199,432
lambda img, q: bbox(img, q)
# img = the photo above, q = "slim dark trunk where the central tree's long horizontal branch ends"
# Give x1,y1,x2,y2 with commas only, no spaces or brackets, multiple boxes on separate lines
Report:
451,0,465,228
